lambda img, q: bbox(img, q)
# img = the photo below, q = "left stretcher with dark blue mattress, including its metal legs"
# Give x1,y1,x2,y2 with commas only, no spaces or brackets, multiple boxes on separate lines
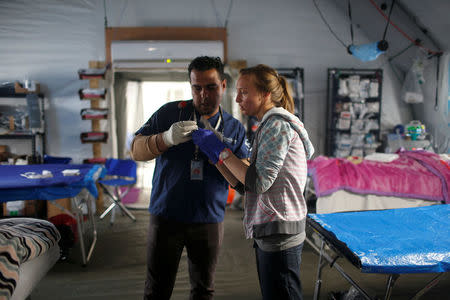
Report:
0,164,106,266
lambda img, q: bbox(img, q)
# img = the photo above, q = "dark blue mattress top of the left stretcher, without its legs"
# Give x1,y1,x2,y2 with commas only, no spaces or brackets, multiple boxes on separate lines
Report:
0,164,105,202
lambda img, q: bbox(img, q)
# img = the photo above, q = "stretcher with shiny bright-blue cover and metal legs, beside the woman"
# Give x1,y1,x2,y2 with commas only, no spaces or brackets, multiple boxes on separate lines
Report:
306,204,450,299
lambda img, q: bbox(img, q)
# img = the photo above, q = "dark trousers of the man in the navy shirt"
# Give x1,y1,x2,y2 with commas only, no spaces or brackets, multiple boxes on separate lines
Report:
144,215,223,300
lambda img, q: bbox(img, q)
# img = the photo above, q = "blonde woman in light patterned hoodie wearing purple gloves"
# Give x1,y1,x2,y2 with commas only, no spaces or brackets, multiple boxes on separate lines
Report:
192,65,314,299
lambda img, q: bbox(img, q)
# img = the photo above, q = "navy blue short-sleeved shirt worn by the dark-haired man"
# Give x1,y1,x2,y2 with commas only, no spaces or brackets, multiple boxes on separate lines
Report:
136,100,248,223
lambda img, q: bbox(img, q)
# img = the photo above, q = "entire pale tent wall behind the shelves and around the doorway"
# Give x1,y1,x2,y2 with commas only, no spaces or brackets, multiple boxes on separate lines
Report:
0,0,418,162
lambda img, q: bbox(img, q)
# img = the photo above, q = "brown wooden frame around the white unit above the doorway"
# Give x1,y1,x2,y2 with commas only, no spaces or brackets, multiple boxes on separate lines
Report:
105,27,228,64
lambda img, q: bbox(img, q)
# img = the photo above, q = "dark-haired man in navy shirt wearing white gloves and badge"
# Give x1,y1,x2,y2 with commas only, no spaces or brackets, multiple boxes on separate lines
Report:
131,56,248,299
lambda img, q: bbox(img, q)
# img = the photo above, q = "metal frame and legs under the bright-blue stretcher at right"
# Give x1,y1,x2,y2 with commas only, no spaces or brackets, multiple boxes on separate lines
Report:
306,216,447,300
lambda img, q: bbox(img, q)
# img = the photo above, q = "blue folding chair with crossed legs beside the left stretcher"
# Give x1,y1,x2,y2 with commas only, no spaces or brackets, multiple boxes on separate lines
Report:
98,158,137,225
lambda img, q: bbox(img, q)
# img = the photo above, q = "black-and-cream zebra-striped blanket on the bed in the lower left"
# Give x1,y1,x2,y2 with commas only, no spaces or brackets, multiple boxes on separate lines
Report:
0,218,61,300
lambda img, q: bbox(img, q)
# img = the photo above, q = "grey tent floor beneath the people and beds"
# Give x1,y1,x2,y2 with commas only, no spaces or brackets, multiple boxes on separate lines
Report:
31,209,450,300
